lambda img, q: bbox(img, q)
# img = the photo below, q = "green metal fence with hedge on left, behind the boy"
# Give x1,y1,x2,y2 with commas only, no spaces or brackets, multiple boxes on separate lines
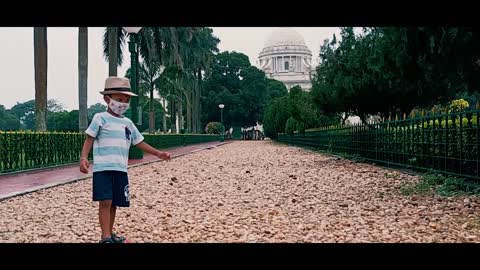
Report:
0,131,221,174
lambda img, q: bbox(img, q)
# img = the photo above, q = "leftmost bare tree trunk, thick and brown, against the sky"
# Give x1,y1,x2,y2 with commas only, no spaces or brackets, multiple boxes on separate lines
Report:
33,27,48,131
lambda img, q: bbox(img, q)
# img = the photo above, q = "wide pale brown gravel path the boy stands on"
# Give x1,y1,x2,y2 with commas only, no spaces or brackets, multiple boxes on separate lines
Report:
0,141,480,242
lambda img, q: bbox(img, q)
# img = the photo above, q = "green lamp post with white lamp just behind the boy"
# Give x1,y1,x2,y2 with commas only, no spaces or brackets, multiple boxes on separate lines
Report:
123,27,142,125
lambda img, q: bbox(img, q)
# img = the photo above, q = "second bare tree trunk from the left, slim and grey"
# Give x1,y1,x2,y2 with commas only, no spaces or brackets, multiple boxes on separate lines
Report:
78,27,88,132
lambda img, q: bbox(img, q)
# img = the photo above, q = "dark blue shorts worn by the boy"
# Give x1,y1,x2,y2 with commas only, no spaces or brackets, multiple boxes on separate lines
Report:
93,171,130,207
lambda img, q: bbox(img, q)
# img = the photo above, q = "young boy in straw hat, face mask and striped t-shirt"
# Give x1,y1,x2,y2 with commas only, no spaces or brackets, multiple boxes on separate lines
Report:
80,77,170,243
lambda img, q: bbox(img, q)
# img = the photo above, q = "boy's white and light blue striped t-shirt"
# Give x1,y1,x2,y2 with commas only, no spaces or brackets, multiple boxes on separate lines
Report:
85,112,144,172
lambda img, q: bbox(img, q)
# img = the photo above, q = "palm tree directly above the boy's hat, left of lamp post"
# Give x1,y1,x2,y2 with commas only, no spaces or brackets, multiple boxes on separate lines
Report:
103,27,127,76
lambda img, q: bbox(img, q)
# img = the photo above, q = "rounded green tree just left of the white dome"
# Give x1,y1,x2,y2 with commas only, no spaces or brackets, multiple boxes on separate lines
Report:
202,52,287,126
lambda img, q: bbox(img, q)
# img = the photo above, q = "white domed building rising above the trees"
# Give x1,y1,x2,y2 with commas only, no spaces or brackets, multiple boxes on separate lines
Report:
258,28,312,91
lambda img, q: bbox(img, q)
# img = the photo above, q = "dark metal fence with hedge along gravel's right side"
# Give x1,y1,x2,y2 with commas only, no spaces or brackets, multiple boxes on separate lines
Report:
278,110,480,180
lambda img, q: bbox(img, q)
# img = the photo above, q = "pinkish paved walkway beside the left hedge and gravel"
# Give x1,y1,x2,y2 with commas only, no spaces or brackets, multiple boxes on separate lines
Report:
0,141,228,200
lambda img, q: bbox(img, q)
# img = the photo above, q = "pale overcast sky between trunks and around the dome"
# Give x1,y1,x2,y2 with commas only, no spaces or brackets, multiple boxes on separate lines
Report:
0,27,340,110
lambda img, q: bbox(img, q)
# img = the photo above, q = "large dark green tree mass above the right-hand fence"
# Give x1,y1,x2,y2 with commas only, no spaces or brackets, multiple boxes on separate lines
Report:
312,26,480,119
